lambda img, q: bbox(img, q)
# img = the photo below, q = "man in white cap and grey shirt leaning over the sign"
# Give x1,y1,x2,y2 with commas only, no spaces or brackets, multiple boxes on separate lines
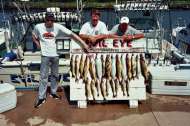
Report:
110,17,144,47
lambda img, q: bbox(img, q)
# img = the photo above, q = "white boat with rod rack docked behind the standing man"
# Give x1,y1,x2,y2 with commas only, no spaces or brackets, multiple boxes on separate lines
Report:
0,0,80,89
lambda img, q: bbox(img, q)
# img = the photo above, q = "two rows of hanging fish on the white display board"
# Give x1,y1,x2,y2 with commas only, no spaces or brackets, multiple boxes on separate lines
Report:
70,53,148,100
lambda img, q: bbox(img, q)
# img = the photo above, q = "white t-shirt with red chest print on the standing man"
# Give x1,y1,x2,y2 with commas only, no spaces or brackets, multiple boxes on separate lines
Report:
32,23,72,57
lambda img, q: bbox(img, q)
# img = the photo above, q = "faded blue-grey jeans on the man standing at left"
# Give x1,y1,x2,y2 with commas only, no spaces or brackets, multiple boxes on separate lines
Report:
38,56,59,99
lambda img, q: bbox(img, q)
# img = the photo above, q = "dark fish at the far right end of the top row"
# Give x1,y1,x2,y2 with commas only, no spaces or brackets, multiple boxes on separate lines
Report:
140,54,148,81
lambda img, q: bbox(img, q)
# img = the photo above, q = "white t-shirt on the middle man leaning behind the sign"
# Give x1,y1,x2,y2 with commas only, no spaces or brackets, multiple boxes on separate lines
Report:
79,21,108,35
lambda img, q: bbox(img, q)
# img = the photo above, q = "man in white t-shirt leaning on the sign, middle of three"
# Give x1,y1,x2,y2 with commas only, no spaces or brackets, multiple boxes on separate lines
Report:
79,10,108,45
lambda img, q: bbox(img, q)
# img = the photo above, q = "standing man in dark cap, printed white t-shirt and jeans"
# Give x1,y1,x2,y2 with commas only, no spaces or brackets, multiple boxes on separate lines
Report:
32,12,88,108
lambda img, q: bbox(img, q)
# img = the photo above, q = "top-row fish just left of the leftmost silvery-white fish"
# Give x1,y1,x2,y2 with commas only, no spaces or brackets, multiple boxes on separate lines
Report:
89,56,96,80
